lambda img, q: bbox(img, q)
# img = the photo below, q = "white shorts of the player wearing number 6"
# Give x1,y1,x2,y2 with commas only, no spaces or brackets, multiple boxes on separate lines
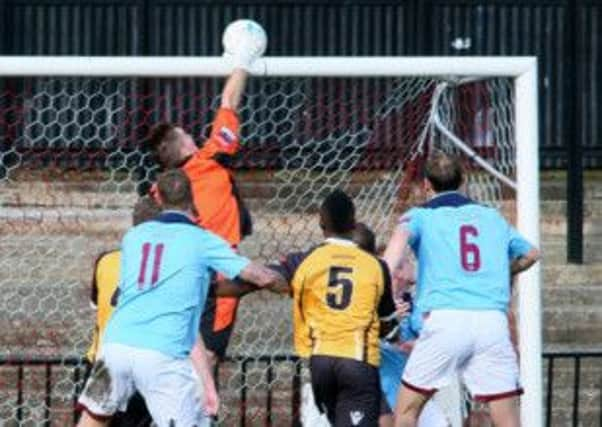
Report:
402,310,522,402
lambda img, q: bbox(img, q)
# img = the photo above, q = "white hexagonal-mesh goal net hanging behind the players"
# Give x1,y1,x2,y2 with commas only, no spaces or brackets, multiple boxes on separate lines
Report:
0,58,539,426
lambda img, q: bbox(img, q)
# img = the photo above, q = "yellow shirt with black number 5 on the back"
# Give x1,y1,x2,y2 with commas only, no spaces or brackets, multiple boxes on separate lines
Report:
291,239,394,366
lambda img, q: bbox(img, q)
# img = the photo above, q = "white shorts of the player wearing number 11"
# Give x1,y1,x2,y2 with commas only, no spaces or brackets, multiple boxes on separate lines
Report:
78,343,210,427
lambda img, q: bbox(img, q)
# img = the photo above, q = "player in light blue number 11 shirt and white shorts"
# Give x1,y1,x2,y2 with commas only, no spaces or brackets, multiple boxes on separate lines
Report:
78,170,282,427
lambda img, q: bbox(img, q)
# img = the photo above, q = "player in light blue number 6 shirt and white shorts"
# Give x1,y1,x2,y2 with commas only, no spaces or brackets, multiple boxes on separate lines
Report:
384,153,539,427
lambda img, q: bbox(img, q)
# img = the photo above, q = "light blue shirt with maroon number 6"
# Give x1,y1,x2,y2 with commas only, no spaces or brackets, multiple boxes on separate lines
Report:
399,192,532,313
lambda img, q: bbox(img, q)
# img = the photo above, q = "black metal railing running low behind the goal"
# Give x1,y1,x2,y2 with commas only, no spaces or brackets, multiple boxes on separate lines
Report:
0,351,602,427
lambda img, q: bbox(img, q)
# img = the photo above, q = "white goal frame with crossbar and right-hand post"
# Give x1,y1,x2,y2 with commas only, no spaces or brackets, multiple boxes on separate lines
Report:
0,56,543,427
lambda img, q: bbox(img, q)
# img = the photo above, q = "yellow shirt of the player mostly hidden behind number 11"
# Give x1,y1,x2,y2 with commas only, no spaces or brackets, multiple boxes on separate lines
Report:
86,250,121,362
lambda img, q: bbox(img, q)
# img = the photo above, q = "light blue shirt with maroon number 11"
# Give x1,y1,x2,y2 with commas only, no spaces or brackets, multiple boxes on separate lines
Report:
103,211,249,358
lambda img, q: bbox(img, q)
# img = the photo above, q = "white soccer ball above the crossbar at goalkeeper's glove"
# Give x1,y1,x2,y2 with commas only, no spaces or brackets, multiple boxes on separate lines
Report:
222,19,268,57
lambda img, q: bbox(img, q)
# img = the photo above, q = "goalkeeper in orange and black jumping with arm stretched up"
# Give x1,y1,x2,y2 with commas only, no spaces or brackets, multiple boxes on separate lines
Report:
149,43,261,372
